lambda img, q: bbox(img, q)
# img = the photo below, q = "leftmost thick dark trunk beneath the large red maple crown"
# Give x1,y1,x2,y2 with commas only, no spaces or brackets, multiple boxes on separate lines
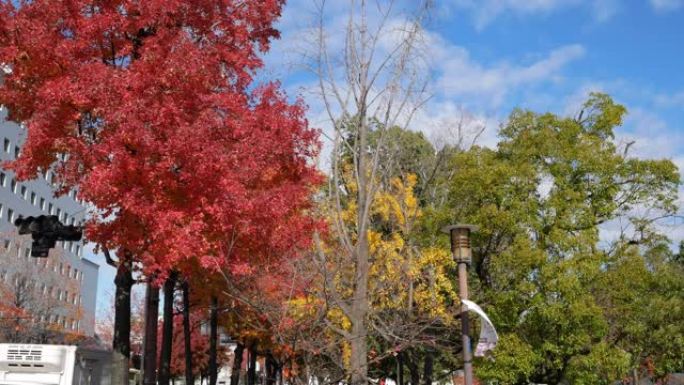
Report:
112,256,133,384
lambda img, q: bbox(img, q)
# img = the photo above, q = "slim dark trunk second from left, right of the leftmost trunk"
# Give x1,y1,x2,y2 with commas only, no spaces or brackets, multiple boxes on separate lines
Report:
143,282,159,385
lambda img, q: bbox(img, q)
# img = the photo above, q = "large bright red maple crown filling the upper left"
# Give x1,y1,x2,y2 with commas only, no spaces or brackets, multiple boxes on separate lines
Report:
0,0,320,380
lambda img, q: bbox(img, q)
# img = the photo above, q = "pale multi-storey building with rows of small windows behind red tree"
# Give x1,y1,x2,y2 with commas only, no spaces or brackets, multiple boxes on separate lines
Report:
0,108,99,336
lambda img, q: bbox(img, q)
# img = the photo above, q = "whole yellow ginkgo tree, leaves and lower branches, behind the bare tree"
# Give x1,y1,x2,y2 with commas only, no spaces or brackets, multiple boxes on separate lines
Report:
289,166,459,379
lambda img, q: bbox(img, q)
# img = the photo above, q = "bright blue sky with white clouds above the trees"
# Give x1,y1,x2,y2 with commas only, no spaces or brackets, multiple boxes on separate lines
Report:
95,0,684,318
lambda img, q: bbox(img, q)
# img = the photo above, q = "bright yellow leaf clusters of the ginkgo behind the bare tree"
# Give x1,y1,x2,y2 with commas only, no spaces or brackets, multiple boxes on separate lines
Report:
314,169,459,344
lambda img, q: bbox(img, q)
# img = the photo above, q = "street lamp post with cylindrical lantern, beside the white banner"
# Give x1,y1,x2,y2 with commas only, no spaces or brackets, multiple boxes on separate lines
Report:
442,224,477,385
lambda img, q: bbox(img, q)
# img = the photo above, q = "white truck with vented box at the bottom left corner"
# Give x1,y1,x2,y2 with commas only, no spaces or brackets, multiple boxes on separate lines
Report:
0,344,111,385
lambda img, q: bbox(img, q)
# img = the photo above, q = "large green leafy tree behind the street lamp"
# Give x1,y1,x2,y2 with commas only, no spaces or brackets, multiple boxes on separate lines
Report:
440,94,684,384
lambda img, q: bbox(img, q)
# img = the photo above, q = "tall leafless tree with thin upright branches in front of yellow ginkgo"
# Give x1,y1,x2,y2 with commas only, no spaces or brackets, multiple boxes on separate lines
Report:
311,0,429,385
